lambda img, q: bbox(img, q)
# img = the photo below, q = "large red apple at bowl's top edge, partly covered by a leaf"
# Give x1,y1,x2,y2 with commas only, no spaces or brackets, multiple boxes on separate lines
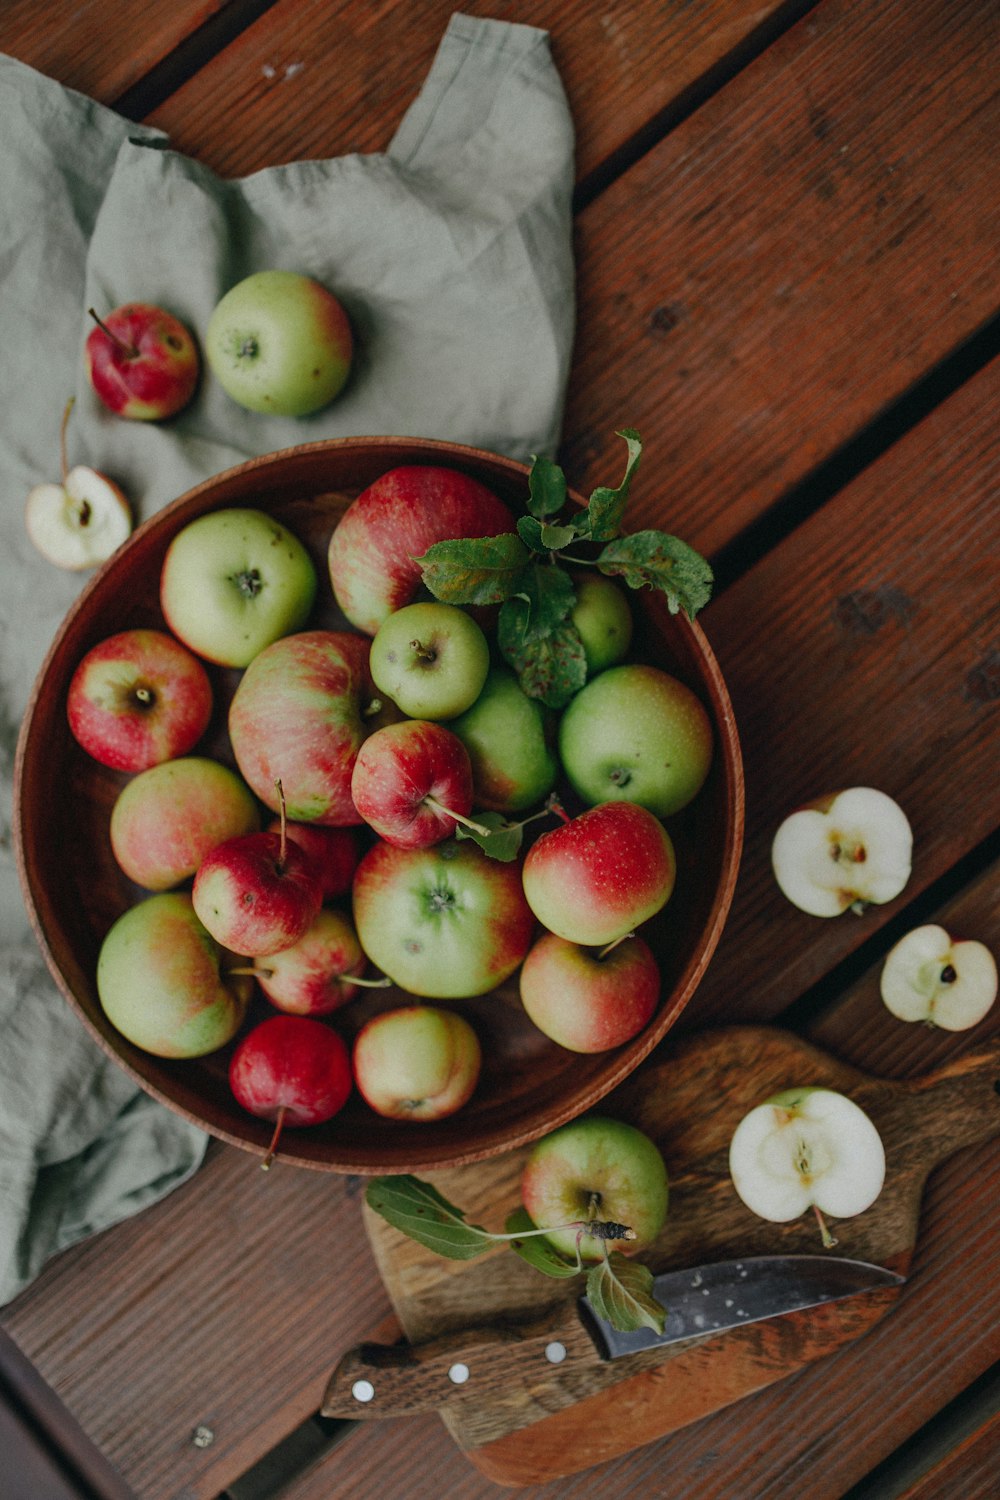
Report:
330,464,514,636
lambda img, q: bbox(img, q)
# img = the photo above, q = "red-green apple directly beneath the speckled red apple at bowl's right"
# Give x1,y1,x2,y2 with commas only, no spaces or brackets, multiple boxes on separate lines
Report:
520,933,660,1053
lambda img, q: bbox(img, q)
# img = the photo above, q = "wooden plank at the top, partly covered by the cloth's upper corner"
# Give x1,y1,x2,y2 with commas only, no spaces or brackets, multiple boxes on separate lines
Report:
137,0,804,177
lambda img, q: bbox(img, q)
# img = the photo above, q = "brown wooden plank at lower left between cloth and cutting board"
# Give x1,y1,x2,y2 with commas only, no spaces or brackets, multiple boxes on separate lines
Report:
0,1146,390,1500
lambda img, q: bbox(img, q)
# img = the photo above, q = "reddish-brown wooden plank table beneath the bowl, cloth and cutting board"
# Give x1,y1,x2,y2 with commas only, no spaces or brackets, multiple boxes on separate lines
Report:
0,0,1000,1500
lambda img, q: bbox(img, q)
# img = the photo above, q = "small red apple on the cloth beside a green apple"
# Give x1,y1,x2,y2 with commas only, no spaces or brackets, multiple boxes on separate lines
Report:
84,302,201,422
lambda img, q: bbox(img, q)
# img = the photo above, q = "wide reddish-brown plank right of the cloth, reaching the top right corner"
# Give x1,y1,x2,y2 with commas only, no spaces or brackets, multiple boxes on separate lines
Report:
562,0,1000,534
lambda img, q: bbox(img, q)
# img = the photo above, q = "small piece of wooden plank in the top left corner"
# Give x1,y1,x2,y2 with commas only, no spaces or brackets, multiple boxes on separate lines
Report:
0,0,229,105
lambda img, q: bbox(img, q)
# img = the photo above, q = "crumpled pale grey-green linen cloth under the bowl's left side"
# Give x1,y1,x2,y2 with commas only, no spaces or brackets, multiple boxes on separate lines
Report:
0,15,574,1305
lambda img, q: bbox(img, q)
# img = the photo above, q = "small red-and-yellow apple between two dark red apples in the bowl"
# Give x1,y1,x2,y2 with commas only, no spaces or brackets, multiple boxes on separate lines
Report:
253,906,371,1016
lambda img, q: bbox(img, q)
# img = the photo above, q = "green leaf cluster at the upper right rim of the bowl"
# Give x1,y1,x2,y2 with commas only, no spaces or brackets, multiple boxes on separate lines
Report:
417,428,712,710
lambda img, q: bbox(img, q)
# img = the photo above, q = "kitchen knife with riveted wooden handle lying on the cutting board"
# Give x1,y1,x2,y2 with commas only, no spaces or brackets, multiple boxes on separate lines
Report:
321,1256,904,1419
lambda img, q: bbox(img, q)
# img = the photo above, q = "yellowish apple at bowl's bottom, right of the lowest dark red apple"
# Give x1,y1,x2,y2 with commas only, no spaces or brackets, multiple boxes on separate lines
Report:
352,1005,481,1121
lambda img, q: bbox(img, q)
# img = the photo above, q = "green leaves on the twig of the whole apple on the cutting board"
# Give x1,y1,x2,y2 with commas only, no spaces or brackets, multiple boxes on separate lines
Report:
366,1175,666,1332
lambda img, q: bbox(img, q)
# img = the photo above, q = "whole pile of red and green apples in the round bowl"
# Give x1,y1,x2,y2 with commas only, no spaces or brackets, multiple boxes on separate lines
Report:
67,465,714,1158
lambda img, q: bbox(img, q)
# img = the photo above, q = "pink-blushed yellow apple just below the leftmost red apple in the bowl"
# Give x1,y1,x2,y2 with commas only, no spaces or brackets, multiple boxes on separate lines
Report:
111,756,261,891
